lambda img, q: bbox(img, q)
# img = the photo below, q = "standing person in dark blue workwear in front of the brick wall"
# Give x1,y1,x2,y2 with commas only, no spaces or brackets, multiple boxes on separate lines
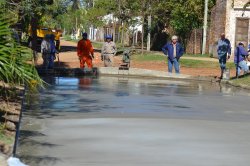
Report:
217,33,231,79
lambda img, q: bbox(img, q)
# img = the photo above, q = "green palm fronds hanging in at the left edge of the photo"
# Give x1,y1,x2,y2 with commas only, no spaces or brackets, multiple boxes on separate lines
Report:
0,13,43,86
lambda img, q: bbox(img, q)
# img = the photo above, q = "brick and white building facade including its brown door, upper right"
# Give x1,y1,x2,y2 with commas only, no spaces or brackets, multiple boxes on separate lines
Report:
208,0,250,56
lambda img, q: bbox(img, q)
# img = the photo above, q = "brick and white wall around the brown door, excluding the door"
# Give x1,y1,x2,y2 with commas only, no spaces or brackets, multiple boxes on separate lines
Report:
209,0,250,57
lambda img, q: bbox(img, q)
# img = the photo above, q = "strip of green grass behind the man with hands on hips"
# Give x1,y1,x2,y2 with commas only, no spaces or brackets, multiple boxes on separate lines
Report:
132,53,235,69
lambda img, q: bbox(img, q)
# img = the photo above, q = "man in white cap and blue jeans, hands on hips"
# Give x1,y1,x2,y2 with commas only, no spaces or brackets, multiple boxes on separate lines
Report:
162,36,184,73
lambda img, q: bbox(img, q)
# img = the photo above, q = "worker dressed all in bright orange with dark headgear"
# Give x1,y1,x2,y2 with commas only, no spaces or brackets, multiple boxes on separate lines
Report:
77,33,94,69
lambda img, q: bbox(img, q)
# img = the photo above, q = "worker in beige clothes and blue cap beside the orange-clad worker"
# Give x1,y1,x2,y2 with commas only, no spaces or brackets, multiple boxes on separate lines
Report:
101,35,117,67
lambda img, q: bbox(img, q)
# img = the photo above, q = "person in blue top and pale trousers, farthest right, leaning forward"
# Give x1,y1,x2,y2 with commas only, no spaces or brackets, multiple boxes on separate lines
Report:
234,42,249,76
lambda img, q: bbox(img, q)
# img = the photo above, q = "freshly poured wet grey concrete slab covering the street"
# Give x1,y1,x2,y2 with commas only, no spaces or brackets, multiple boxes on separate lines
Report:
18,77,250,166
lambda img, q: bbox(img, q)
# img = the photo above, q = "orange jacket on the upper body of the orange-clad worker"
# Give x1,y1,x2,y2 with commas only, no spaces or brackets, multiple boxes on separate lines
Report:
77,39,94,56
